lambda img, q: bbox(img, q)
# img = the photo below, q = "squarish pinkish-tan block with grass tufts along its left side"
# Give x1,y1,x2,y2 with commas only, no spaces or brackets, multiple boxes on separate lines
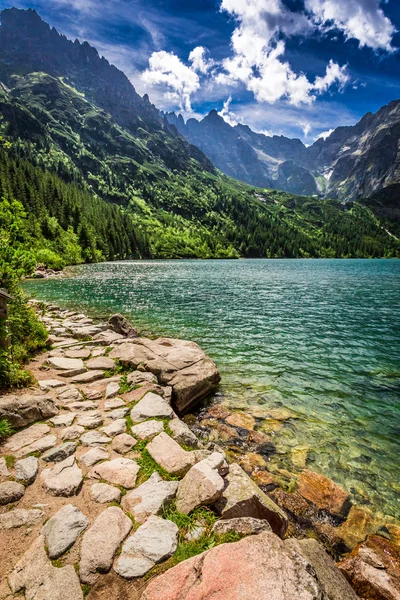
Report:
146,432,196,476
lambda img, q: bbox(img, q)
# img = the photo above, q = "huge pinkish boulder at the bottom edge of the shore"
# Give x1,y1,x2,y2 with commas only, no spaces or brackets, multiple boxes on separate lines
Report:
141,532,357,600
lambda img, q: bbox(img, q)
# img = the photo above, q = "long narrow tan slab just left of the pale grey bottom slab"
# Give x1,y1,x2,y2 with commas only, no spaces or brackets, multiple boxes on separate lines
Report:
79,506,132,585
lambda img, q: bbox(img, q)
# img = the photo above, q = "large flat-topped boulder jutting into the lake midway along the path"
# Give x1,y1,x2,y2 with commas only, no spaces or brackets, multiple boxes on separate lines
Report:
109,338,220,412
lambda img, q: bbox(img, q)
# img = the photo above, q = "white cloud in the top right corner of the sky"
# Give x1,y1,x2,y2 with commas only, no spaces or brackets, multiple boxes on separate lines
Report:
305,0,396,52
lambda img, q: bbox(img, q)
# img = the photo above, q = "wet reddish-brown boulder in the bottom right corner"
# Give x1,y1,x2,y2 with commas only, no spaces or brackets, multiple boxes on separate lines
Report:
338,535,400,600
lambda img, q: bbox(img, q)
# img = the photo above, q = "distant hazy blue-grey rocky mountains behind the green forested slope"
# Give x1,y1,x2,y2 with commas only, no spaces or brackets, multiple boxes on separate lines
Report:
166,100,400,201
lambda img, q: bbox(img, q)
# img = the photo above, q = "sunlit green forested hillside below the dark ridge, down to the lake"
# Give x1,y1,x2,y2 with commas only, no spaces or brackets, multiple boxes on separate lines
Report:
0,73,400,266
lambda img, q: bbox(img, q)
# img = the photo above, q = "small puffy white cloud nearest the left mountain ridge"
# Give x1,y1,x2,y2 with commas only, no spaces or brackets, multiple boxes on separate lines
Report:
142,51,200,113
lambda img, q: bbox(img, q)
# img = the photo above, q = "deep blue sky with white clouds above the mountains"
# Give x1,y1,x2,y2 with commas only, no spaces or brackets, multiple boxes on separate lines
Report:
0,0,400,144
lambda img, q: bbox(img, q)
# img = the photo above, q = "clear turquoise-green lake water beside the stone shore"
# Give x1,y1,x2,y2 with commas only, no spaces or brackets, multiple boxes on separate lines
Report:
26,260,400,517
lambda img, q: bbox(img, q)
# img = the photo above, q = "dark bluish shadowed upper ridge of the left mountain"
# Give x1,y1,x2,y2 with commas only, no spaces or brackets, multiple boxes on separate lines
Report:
0,8,213,171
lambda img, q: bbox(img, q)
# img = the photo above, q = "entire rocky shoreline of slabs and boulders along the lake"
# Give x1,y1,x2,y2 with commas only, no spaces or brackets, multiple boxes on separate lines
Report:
0,302,400,600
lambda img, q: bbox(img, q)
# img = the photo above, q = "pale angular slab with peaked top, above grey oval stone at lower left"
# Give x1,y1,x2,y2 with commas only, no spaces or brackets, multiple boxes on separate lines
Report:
40,456,83,497
